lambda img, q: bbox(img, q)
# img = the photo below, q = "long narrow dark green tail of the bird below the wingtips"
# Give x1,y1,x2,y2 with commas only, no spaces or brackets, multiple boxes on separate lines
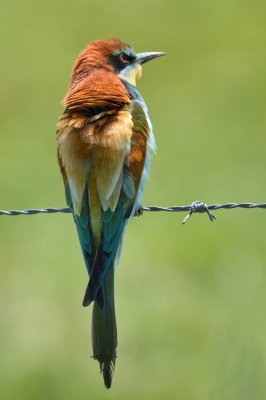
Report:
92,264,117,389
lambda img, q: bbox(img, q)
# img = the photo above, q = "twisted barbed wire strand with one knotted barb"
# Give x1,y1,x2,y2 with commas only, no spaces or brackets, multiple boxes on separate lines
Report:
0,200,266,224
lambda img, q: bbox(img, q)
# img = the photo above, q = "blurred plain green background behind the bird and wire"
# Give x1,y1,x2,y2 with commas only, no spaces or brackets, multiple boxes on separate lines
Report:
0,0,266,400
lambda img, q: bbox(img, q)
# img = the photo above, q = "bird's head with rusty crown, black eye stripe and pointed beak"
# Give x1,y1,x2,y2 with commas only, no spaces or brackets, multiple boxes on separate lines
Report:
73,39,165,86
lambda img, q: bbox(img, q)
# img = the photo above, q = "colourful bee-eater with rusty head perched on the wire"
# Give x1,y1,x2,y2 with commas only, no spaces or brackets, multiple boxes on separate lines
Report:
57,39,164,388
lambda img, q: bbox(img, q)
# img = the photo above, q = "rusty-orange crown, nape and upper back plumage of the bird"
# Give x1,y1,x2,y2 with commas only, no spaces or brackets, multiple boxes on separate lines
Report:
63,39,130,110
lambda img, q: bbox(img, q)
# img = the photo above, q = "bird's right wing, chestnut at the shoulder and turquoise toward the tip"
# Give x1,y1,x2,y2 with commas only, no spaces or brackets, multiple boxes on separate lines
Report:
83,95,154,305
